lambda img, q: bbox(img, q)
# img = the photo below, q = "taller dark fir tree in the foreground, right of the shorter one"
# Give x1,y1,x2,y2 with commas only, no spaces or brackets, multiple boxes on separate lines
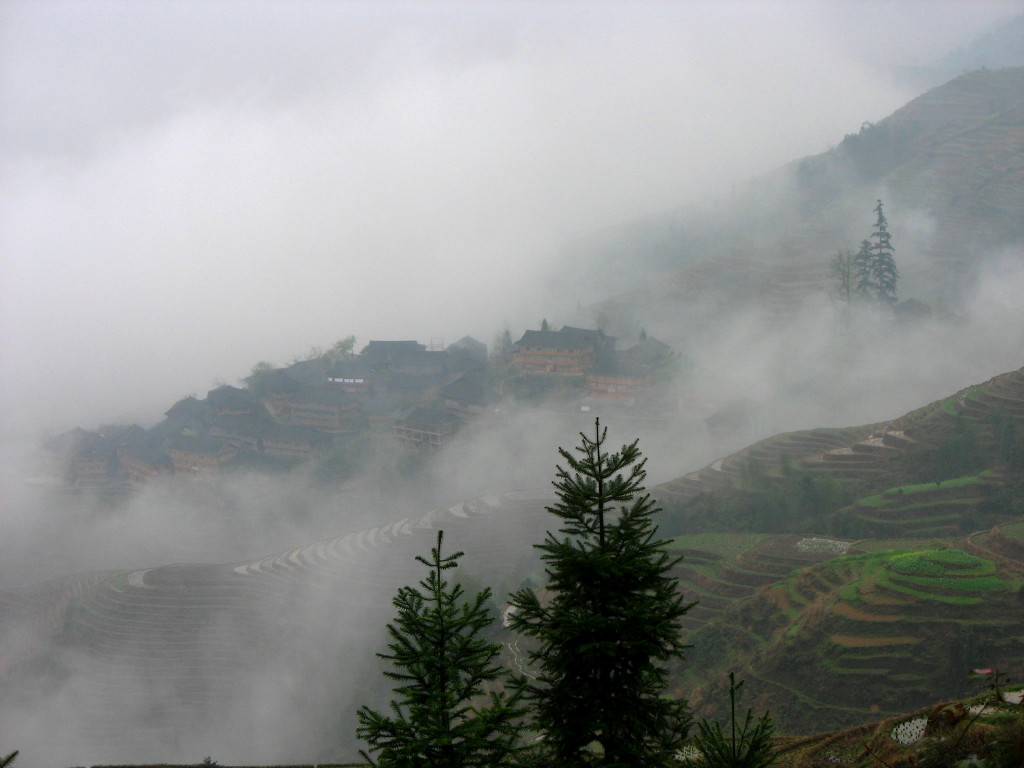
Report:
511,421,692,768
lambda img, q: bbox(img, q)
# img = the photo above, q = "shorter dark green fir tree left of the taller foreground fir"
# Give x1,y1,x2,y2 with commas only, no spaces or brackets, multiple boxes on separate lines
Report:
356,531,524,768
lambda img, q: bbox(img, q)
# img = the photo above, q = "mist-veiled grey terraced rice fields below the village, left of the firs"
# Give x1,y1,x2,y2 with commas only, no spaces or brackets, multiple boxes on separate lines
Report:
0,494,549,762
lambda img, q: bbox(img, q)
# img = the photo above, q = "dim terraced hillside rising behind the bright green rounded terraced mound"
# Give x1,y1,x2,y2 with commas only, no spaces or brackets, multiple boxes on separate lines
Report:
651,369,1024,537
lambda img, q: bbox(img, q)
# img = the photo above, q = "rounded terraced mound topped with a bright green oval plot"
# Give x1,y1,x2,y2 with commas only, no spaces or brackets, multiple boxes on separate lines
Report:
688,537,1024,730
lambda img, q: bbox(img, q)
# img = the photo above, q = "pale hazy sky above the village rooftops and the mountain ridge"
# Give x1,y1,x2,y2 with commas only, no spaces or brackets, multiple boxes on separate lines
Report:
0,0,1024,431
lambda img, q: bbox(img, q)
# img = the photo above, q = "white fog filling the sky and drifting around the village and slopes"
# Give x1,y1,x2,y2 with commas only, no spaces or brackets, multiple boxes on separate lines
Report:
0,0,1024,768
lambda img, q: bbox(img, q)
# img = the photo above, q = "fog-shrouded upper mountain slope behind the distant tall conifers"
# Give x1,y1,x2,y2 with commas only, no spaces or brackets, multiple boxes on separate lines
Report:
577,68,1024,312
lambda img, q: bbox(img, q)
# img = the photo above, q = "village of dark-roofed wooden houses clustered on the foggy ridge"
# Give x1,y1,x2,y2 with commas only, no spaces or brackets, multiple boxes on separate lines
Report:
43,321,678,489
